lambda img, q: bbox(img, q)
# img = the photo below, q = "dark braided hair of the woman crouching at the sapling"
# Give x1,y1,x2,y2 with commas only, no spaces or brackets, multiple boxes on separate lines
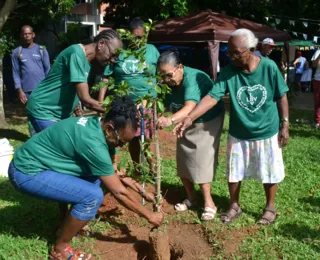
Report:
103,96,138,130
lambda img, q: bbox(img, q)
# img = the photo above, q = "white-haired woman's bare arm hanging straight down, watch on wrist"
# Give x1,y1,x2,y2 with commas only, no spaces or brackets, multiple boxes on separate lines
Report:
277,94,289,147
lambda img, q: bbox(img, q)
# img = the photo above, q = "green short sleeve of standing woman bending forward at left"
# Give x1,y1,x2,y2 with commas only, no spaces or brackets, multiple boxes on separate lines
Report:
69,53,88,83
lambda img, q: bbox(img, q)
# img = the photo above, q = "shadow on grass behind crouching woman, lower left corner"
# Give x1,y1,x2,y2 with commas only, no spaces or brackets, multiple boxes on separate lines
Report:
0,179,58,243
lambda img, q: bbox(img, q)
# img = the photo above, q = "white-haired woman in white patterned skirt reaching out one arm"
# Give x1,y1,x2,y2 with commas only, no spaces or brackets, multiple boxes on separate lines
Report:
174,29,289,225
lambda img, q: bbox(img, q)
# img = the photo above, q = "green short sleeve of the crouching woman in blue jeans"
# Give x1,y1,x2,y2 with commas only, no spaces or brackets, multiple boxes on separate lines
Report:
81,137,114,176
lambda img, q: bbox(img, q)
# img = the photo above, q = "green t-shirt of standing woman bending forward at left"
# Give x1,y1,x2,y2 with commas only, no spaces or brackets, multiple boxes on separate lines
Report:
27,44,91,120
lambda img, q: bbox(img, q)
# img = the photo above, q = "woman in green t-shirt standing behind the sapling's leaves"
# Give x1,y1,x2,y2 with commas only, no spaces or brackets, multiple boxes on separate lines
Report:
98,17,160,174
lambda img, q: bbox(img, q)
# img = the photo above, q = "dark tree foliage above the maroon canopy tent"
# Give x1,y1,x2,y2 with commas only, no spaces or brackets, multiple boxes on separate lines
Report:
103,0,320,38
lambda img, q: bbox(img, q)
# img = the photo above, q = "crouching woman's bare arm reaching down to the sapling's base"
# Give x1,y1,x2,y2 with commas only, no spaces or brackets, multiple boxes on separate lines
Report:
100,174,163,226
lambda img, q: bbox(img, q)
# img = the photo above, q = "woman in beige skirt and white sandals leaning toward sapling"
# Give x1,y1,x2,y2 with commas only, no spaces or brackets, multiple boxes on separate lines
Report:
157,50,224,220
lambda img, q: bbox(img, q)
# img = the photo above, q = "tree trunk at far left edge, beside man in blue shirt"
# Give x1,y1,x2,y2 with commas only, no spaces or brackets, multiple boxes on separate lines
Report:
0,0,17,128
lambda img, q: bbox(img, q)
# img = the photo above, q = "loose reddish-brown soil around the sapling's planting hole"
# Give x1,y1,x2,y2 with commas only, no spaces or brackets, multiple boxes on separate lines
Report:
95,187,214,260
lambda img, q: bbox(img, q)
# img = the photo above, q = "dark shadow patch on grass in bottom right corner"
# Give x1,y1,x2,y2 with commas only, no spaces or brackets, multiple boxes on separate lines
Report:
279,223,320,252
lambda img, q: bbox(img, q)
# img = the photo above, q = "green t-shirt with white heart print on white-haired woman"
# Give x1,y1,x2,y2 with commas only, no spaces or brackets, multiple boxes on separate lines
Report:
209,57,289,140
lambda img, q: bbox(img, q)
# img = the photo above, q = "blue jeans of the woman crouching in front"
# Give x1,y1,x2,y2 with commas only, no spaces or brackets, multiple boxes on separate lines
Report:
8,161,104,221
